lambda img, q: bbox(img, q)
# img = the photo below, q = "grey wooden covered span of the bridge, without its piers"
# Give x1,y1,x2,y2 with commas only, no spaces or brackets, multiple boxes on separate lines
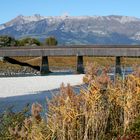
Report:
0,45,140,57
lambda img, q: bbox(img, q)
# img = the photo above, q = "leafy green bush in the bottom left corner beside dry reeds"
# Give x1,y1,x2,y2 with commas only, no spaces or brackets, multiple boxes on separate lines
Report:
0,105,29,140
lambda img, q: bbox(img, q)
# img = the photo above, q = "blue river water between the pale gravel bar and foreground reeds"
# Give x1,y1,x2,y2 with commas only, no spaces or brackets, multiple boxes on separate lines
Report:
0,85,86,113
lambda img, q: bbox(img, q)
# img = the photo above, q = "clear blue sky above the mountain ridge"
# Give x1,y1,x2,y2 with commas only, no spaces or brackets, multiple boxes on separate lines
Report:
0,0,140,24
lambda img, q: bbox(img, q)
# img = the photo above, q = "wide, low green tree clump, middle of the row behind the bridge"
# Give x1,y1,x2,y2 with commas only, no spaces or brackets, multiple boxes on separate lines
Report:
18,37,41,46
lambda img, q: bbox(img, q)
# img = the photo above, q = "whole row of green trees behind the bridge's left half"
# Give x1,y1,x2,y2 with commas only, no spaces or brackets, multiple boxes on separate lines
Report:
0,35,58,47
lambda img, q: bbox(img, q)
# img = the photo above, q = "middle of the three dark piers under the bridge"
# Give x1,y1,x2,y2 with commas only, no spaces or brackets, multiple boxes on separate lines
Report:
76,56,84,74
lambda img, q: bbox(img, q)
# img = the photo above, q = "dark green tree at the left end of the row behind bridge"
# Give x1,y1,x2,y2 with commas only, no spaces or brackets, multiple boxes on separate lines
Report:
0,35,17,47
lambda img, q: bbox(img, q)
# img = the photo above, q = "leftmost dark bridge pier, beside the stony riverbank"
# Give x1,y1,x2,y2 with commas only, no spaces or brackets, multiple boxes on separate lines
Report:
40,56,50,75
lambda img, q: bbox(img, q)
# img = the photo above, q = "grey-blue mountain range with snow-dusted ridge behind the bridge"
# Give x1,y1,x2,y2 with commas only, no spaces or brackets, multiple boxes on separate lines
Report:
0,15,140,44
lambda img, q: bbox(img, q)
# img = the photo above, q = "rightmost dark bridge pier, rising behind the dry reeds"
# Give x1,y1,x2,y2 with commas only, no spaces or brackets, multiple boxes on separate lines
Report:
115,56,122,75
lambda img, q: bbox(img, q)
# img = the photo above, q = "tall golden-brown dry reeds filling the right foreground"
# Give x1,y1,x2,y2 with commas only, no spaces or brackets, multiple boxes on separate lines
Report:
1,63,140,140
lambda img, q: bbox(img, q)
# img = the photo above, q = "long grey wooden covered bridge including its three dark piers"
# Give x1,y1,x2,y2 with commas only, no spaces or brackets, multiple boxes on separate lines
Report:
0,45,140,74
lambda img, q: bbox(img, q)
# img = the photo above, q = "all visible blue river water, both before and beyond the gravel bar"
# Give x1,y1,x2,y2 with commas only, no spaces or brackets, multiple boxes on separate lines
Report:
0,67,133,113
